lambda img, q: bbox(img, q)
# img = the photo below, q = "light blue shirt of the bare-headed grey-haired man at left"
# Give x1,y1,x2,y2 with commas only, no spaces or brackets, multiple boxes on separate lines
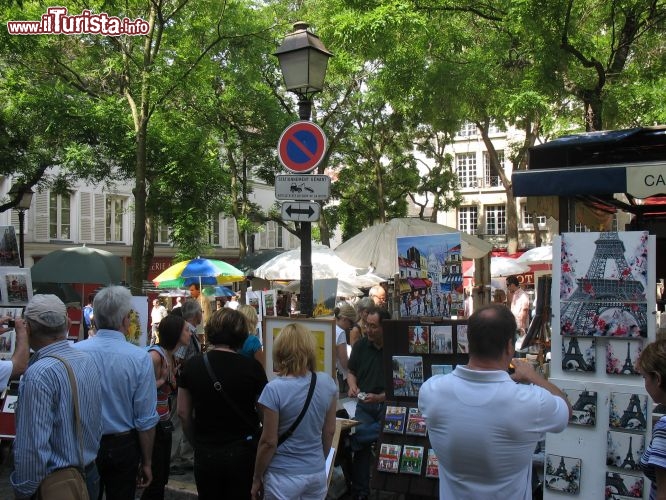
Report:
74,330,159,435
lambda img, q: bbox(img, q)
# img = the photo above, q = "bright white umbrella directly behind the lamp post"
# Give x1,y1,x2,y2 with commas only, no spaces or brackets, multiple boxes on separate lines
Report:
254,243,356,281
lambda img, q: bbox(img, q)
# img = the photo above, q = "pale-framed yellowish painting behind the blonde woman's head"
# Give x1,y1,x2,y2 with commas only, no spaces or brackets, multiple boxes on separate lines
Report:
263,317,336,380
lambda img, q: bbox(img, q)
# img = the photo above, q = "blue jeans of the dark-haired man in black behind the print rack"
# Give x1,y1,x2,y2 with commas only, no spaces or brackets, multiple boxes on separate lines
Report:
350,401,384,496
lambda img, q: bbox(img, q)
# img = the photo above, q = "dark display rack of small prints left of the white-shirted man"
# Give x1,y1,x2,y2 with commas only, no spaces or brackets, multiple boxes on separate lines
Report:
371,318,468,498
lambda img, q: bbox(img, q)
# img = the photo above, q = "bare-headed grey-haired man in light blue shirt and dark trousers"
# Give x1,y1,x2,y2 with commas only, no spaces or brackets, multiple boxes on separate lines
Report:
74,286,159,500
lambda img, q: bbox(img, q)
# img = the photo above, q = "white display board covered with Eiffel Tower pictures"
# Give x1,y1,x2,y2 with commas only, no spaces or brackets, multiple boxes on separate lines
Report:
544,232,656,500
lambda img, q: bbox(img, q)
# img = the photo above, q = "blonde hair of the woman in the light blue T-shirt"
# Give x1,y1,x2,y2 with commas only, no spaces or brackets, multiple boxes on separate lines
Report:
273,323,317,375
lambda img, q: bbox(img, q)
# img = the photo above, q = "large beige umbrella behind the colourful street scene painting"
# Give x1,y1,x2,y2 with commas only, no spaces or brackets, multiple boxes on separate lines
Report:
335,217,492,278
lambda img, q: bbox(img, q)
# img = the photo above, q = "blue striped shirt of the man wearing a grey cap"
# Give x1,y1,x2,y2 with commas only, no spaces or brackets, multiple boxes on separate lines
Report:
11,340,102,497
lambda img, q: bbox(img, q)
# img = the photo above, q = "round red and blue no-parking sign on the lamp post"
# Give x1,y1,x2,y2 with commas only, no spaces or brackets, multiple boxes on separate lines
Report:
278,120,326,174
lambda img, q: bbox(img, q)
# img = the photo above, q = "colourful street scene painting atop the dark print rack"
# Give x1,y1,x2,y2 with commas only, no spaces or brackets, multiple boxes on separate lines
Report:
396,233,464,317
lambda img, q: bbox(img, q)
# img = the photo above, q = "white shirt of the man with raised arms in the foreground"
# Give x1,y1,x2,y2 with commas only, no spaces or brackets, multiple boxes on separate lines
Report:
419,366,569,500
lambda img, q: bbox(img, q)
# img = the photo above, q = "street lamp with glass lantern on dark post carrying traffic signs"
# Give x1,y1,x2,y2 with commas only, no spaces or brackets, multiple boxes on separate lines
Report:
274,22,333,317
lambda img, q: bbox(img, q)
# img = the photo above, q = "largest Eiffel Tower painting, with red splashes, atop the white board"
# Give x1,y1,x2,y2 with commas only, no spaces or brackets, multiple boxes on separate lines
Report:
560,232,647,337
